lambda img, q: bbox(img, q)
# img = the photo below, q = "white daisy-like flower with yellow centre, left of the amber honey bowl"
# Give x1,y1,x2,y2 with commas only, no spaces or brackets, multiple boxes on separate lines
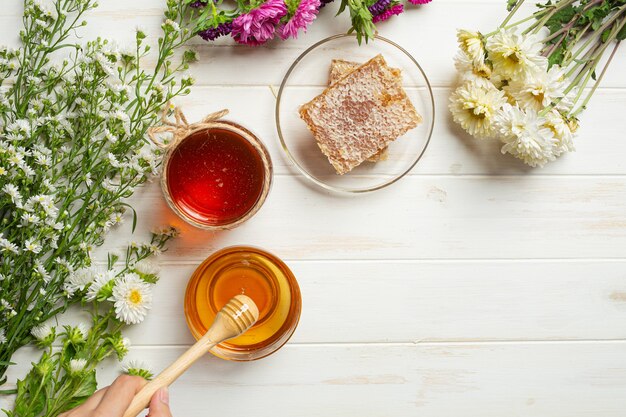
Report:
111,273,152,324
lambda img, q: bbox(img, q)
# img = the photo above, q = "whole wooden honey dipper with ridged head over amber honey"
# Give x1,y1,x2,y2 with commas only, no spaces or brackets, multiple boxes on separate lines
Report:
124,295,259,417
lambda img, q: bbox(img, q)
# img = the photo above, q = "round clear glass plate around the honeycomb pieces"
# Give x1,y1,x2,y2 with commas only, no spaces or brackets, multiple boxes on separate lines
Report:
276,34,435,193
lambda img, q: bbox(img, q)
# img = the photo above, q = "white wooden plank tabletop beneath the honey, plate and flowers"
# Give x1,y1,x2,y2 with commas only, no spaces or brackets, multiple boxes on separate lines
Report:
0,0,626,417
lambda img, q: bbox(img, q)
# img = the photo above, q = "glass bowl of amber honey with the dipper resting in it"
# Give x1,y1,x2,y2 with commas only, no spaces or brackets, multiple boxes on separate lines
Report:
184,246,302,361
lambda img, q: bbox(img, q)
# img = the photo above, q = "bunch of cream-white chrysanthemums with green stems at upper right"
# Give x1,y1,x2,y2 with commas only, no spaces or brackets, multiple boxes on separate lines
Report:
450,0,626,167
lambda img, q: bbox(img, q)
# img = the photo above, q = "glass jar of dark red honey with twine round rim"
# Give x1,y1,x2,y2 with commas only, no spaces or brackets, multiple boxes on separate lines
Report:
161,120,273,230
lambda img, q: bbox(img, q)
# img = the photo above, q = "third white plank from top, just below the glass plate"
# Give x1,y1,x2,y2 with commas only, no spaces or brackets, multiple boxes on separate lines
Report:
95,176,626,261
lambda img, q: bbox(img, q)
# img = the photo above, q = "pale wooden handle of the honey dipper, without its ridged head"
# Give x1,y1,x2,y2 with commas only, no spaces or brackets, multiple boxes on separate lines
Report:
124,334,220,417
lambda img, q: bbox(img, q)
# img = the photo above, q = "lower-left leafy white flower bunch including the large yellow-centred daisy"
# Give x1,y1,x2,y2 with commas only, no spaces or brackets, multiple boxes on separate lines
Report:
5,228,176,417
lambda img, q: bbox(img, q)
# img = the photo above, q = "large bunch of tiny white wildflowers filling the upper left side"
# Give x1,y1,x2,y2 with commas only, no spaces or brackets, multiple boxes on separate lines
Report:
0,0,200,384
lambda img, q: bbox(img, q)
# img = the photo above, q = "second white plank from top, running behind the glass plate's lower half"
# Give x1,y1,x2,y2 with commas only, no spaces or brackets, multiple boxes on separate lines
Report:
171,86,626,176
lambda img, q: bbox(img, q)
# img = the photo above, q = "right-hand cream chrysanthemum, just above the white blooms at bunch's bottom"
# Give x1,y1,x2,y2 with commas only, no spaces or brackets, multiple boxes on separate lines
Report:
505,65,567,111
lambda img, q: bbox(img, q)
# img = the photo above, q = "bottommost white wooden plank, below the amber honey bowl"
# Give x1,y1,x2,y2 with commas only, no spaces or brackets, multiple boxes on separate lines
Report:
5,342,626,417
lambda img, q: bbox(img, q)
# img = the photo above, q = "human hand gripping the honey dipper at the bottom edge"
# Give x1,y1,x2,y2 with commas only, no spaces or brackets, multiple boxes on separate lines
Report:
59,375,172,417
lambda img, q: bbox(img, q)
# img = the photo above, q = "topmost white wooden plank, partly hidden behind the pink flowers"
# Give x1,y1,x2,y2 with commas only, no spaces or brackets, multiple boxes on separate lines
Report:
0,0,626,87
